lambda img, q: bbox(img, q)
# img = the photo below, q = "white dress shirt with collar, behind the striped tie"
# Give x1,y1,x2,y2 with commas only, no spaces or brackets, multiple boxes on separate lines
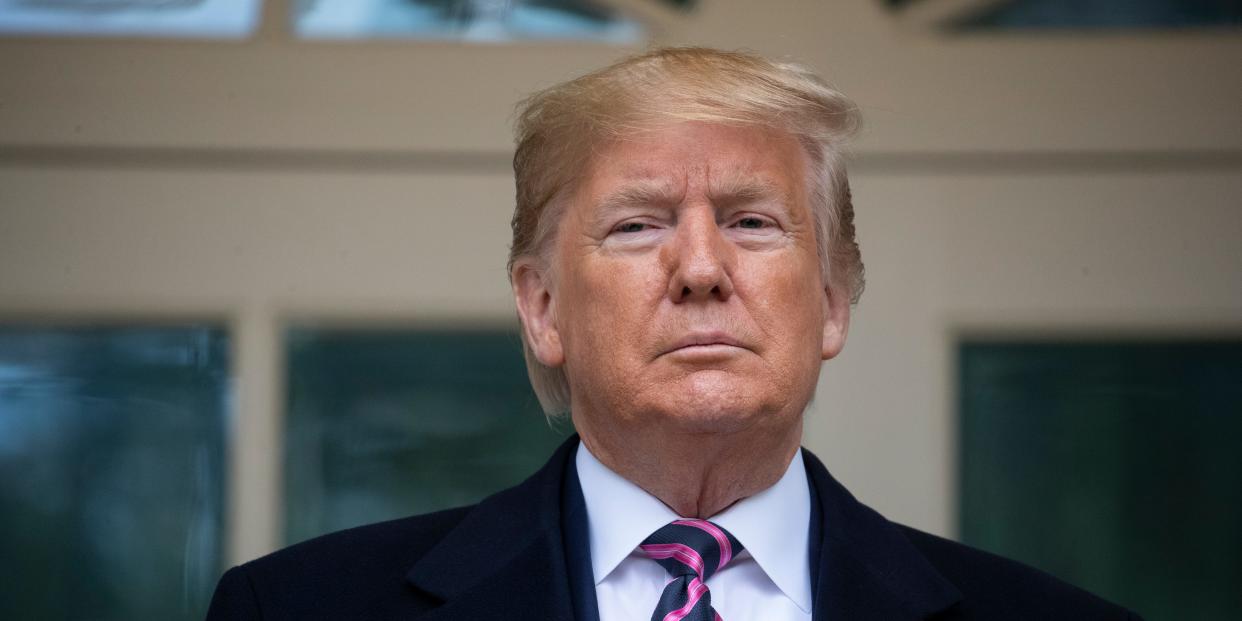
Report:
576,443,811,621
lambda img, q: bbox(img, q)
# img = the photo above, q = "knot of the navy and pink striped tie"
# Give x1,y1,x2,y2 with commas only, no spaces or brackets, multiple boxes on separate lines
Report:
638,519,743,581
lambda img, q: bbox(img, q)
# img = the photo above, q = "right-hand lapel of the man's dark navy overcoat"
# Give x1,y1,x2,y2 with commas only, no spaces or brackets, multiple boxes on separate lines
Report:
802,450,961,621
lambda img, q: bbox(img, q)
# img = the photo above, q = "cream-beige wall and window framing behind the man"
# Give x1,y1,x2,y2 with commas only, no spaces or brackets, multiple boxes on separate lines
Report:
0,0,1242,560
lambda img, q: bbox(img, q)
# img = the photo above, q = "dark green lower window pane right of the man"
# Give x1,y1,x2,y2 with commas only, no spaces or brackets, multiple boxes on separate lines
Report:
960,343,1242,620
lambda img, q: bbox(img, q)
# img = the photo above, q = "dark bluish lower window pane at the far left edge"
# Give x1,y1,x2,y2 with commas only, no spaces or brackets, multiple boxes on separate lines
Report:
0,325,229,621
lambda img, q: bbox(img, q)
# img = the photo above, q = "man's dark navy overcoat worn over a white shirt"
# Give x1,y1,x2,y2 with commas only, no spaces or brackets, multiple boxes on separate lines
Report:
207,437,1138,621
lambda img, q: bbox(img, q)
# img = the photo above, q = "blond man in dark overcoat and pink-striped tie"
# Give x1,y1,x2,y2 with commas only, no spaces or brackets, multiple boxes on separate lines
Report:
209,48,1133,621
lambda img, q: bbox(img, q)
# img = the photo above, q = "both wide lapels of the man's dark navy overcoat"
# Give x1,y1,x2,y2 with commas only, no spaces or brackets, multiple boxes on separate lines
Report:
406,435,961,621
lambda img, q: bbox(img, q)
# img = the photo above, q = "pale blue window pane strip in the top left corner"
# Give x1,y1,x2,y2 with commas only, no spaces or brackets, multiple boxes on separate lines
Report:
0,0,261,39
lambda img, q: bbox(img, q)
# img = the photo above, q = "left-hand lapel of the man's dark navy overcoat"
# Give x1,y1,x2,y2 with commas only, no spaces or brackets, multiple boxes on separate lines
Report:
406,436,578,621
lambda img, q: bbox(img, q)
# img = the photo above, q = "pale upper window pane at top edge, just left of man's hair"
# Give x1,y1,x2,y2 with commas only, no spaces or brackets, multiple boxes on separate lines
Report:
293,0,643,43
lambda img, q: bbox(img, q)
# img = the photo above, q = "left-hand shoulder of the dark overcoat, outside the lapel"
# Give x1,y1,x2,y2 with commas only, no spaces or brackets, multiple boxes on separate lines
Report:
207,507,471,620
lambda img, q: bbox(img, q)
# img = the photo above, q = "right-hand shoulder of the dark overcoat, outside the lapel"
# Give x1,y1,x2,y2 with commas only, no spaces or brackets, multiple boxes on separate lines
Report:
894,524,1139,621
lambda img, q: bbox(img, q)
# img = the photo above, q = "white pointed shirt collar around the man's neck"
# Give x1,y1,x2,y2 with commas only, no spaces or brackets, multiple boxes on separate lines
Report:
575,443,811,612
